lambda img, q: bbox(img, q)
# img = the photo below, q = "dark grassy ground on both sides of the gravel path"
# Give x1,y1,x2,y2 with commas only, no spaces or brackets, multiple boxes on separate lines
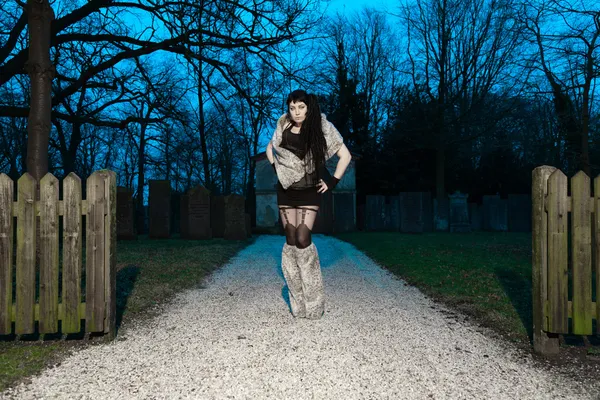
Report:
0,232,600,391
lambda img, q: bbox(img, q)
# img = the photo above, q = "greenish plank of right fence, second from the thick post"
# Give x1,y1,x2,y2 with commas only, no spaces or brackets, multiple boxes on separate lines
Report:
571,171,592,335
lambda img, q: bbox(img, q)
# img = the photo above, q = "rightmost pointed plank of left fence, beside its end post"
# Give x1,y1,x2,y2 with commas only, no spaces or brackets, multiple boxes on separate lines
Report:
85,172,106,332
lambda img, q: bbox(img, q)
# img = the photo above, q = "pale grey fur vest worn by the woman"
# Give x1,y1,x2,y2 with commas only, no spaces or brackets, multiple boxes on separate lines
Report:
271,114,344,189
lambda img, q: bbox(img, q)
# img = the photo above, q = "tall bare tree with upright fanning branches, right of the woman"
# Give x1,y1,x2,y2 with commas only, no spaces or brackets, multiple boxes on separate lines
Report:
401,0,520,199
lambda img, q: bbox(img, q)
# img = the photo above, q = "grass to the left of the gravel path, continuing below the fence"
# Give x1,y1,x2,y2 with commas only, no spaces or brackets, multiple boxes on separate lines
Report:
0,238,254,391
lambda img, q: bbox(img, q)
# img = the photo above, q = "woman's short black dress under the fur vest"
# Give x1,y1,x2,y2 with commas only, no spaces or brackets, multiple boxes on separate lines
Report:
277,126,321,207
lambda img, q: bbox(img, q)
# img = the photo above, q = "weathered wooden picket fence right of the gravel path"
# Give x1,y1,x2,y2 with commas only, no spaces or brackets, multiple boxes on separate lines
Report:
532,166,600,354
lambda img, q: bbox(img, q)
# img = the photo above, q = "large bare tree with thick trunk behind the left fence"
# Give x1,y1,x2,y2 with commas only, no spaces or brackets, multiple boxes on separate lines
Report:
0,0,324,175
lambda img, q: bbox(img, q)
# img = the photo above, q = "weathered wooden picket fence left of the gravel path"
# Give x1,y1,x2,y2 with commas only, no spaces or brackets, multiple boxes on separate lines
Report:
0,170,116,338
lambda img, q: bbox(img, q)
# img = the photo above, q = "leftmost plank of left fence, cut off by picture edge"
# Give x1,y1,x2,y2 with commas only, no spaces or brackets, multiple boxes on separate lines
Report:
0,174,14,335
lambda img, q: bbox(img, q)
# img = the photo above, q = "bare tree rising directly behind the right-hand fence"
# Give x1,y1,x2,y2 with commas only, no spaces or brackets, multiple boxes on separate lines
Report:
520,0,600,175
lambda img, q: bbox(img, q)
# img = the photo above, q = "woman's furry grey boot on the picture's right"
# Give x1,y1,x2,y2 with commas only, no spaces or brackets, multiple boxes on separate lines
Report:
296,243,325,319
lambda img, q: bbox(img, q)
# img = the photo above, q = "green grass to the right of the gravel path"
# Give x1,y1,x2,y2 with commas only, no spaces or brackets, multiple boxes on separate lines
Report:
336,232,532,343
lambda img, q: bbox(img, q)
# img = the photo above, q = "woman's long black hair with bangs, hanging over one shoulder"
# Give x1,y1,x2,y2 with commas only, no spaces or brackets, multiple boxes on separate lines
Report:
286,90,327,179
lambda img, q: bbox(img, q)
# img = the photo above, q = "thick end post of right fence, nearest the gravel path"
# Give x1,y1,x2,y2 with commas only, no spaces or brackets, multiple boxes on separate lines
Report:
531,165,558,354
